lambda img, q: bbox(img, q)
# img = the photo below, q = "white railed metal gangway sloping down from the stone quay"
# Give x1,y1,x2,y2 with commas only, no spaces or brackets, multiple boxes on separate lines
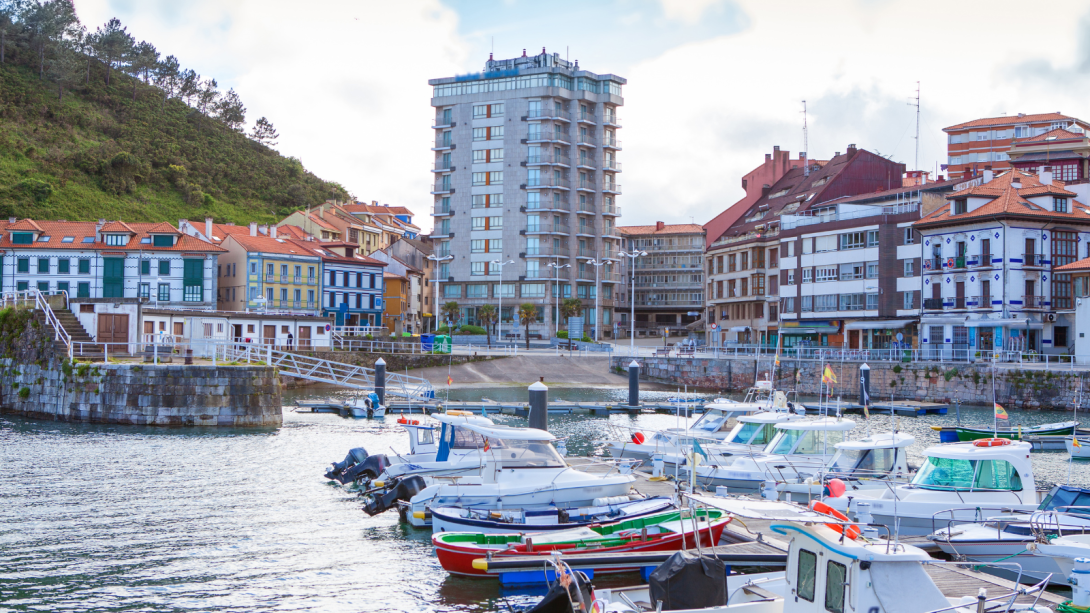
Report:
223,344,435,402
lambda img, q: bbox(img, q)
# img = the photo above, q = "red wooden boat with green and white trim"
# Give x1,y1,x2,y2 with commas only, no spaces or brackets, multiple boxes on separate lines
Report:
432,509,730,577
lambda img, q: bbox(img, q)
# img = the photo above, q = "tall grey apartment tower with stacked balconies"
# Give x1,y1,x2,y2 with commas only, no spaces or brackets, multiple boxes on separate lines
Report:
428,49,627,337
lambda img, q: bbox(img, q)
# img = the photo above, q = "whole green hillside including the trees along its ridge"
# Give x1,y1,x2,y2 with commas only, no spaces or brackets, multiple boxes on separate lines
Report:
0,0,348,224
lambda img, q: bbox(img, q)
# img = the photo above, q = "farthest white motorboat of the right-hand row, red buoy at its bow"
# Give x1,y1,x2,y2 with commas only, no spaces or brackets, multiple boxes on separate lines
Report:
605,382,789,461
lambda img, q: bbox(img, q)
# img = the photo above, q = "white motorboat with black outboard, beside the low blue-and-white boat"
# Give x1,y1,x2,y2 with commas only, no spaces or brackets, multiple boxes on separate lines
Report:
394,423,635,527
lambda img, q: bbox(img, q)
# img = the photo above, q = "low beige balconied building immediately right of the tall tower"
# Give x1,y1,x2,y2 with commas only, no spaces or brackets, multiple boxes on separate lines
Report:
619,221,704,337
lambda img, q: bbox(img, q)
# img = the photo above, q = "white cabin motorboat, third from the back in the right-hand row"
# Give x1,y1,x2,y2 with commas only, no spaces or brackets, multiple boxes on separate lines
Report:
682,417,856,492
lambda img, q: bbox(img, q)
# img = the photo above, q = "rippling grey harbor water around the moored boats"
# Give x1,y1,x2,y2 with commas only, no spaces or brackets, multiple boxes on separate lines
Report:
0,387,1090,612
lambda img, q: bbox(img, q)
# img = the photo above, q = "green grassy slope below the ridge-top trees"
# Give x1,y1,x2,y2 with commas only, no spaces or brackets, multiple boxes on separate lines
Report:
0,63,347,224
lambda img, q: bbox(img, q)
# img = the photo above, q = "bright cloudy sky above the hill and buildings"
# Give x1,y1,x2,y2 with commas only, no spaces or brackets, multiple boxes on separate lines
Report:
75,0,1090,229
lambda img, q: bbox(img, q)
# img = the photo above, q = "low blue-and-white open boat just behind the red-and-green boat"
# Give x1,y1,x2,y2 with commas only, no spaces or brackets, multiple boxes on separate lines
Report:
432,496,676,533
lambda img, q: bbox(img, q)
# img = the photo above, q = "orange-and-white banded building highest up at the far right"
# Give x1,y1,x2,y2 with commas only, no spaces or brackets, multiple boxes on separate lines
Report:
943,112,1090,180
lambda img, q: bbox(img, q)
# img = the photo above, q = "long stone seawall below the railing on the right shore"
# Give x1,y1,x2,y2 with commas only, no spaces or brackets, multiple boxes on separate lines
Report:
609,356,1090,410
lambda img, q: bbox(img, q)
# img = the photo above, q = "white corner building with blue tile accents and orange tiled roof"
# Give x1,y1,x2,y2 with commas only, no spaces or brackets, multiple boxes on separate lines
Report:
913,167,1090,358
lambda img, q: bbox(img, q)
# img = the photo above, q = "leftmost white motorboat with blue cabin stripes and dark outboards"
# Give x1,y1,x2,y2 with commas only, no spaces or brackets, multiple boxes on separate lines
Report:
325,411,493,486
